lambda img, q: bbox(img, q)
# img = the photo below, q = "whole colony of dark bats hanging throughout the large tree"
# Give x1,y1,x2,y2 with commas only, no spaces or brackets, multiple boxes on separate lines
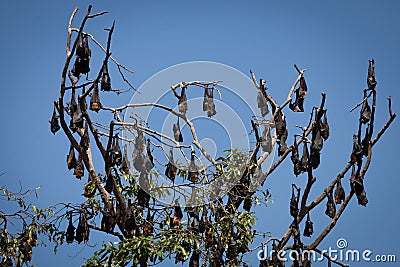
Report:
52,25,382,267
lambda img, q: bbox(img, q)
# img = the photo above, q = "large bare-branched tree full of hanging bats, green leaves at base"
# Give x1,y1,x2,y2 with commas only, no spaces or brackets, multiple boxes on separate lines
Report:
43,6,396,266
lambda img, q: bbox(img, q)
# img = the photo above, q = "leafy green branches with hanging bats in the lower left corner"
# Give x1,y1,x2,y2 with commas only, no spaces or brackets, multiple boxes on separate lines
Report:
0,177,64,266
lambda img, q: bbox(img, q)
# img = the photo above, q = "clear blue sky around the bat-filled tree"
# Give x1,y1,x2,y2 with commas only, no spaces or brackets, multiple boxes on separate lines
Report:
0,0,400,267
